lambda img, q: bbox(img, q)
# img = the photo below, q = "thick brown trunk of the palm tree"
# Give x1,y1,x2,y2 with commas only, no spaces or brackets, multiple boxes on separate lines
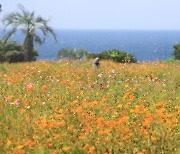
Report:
24,34,34,62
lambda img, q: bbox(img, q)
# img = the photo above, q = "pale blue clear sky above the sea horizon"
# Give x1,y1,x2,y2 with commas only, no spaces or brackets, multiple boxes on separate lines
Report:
0,0,180,30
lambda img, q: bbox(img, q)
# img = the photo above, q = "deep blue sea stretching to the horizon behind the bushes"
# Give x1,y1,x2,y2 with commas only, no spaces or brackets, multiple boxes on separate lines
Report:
2,30,180,61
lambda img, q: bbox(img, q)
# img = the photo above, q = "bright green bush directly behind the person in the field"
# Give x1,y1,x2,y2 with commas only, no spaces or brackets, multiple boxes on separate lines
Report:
88,49,137,63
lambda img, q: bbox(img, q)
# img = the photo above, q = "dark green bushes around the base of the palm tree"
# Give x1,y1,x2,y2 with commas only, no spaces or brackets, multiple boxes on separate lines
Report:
0,40,38,63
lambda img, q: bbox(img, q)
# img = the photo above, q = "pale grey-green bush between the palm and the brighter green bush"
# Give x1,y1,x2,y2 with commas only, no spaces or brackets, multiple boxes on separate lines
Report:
57,48,89,59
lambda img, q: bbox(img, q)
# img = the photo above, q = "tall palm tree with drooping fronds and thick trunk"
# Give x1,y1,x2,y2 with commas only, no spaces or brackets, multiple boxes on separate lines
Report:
2,5,57,61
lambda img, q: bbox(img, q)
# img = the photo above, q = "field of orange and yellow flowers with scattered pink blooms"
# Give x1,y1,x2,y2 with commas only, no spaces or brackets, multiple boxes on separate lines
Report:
0,60,180,154
